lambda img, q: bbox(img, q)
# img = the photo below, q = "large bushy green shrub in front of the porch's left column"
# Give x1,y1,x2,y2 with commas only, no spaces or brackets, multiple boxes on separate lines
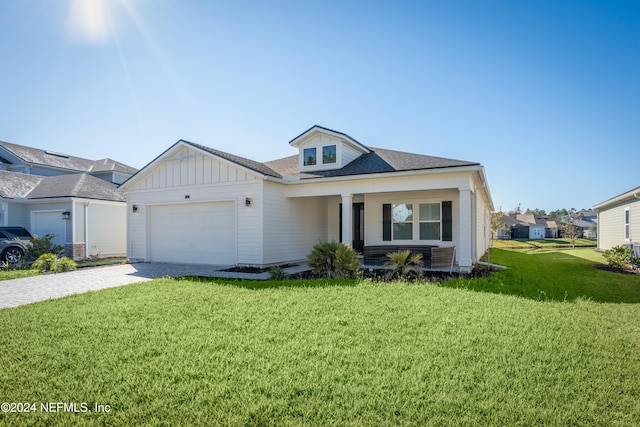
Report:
307,241,360,278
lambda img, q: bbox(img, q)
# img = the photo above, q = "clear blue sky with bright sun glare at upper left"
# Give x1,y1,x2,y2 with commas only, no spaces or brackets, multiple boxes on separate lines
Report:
0,0,640,212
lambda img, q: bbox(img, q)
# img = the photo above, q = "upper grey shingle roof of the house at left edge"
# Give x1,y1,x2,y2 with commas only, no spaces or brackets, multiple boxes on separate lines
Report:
0,141,136,174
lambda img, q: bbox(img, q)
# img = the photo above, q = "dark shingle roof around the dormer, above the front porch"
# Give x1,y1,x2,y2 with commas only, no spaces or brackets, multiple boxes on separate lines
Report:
265,147,479,179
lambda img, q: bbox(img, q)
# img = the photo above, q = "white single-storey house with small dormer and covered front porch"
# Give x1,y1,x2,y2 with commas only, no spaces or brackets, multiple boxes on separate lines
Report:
120,126,493,272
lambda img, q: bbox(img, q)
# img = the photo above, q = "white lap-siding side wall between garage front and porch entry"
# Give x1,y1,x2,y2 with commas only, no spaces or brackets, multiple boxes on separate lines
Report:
263,182,328,264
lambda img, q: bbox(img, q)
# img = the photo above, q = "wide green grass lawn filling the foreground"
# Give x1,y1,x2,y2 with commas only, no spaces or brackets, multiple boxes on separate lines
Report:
0,250,640,426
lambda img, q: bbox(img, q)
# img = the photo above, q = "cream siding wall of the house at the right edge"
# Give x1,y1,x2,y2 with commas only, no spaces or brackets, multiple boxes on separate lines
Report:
598,199,640,251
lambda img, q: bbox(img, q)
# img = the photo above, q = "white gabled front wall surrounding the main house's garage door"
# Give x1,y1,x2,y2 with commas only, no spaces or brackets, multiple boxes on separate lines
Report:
127,146,263,265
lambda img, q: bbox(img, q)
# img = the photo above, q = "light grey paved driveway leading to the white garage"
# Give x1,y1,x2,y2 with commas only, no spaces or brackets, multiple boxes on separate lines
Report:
0,263,228,308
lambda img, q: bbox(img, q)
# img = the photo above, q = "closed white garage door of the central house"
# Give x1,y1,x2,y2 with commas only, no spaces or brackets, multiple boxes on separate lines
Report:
148,202,236,264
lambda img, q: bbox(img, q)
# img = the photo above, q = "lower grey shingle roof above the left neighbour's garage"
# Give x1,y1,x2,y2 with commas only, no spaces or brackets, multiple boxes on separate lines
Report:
0,171,125,202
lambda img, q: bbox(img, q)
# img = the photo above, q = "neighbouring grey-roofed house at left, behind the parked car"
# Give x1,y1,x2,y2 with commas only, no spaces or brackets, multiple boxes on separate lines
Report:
0,141,136,259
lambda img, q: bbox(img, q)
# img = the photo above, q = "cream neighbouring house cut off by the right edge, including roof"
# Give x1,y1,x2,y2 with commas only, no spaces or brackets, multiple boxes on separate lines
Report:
593,187,640,253
